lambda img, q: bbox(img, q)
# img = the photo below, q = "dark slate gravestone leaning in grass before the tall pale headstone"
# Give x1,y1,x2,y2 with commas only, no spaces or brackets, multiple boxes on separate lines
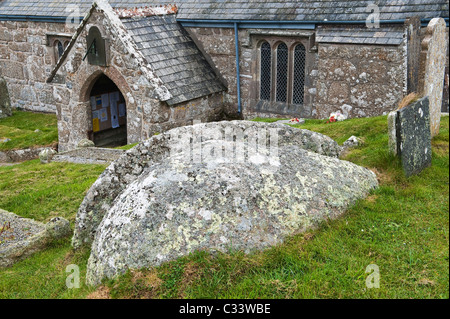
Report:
395,97,431,177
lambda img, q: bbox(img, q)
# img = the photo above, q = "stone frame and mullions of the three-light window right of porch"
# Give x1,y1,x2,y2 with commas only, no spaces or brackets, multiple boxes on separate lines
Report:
253,35,315,105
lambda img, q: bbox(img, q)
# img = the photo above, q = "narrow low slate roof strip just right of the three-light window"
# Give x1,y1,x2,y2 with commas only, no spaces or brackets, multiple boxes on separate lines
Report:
316,26,404,45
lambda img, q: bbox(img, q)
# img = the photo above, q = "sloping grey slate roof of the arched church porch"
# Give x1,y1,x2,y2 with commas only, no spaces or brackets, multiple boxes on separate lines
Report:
122,15,224,105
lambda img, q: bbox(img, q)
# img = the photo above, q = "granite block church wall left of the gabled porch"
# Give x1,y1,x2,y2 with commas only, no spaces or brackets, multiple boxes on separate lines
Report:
0,21,74,113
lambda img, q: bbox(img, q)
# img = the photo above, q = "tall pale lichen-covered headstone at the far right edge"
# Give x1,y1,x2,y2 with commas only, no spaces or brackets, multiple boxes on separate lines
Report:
421,18,447,137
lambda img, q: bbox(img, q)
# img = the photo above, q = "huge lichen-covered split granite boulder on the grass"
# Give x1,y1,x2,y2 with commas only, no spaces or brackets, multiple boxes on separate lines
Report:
73,121,378,284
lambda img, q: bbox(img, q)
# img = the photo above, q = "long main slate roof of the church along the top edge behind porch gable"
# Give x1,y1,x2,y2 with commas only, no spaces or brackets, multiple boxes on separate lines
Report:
0,0,449,21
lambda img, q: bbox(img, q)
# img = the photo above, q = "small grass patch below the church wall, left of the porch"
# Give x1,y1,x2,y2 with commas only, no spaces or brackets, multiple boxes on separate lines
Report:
0,111,58,151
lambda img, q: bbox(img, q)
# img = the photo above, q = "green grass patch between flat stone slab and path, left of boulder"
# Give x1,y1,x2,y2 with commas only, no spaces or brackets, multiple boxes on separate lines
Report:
0,160,106,222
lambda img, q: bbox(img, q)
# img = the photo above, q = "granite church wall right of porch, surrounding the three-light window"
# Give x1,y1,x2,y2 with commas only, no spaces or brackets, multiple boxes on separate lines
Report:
189,28,407,118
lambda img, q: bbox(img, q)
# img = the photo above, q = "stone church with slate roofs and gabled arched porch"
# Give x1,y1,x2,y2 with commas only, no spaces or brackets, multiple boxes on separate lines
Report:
0,0,449,150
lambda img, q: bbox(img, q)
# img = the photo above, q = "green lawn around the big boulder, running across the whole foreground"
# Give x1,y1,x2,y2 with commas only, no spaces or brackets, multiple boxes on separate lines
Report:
0,116,449,298
